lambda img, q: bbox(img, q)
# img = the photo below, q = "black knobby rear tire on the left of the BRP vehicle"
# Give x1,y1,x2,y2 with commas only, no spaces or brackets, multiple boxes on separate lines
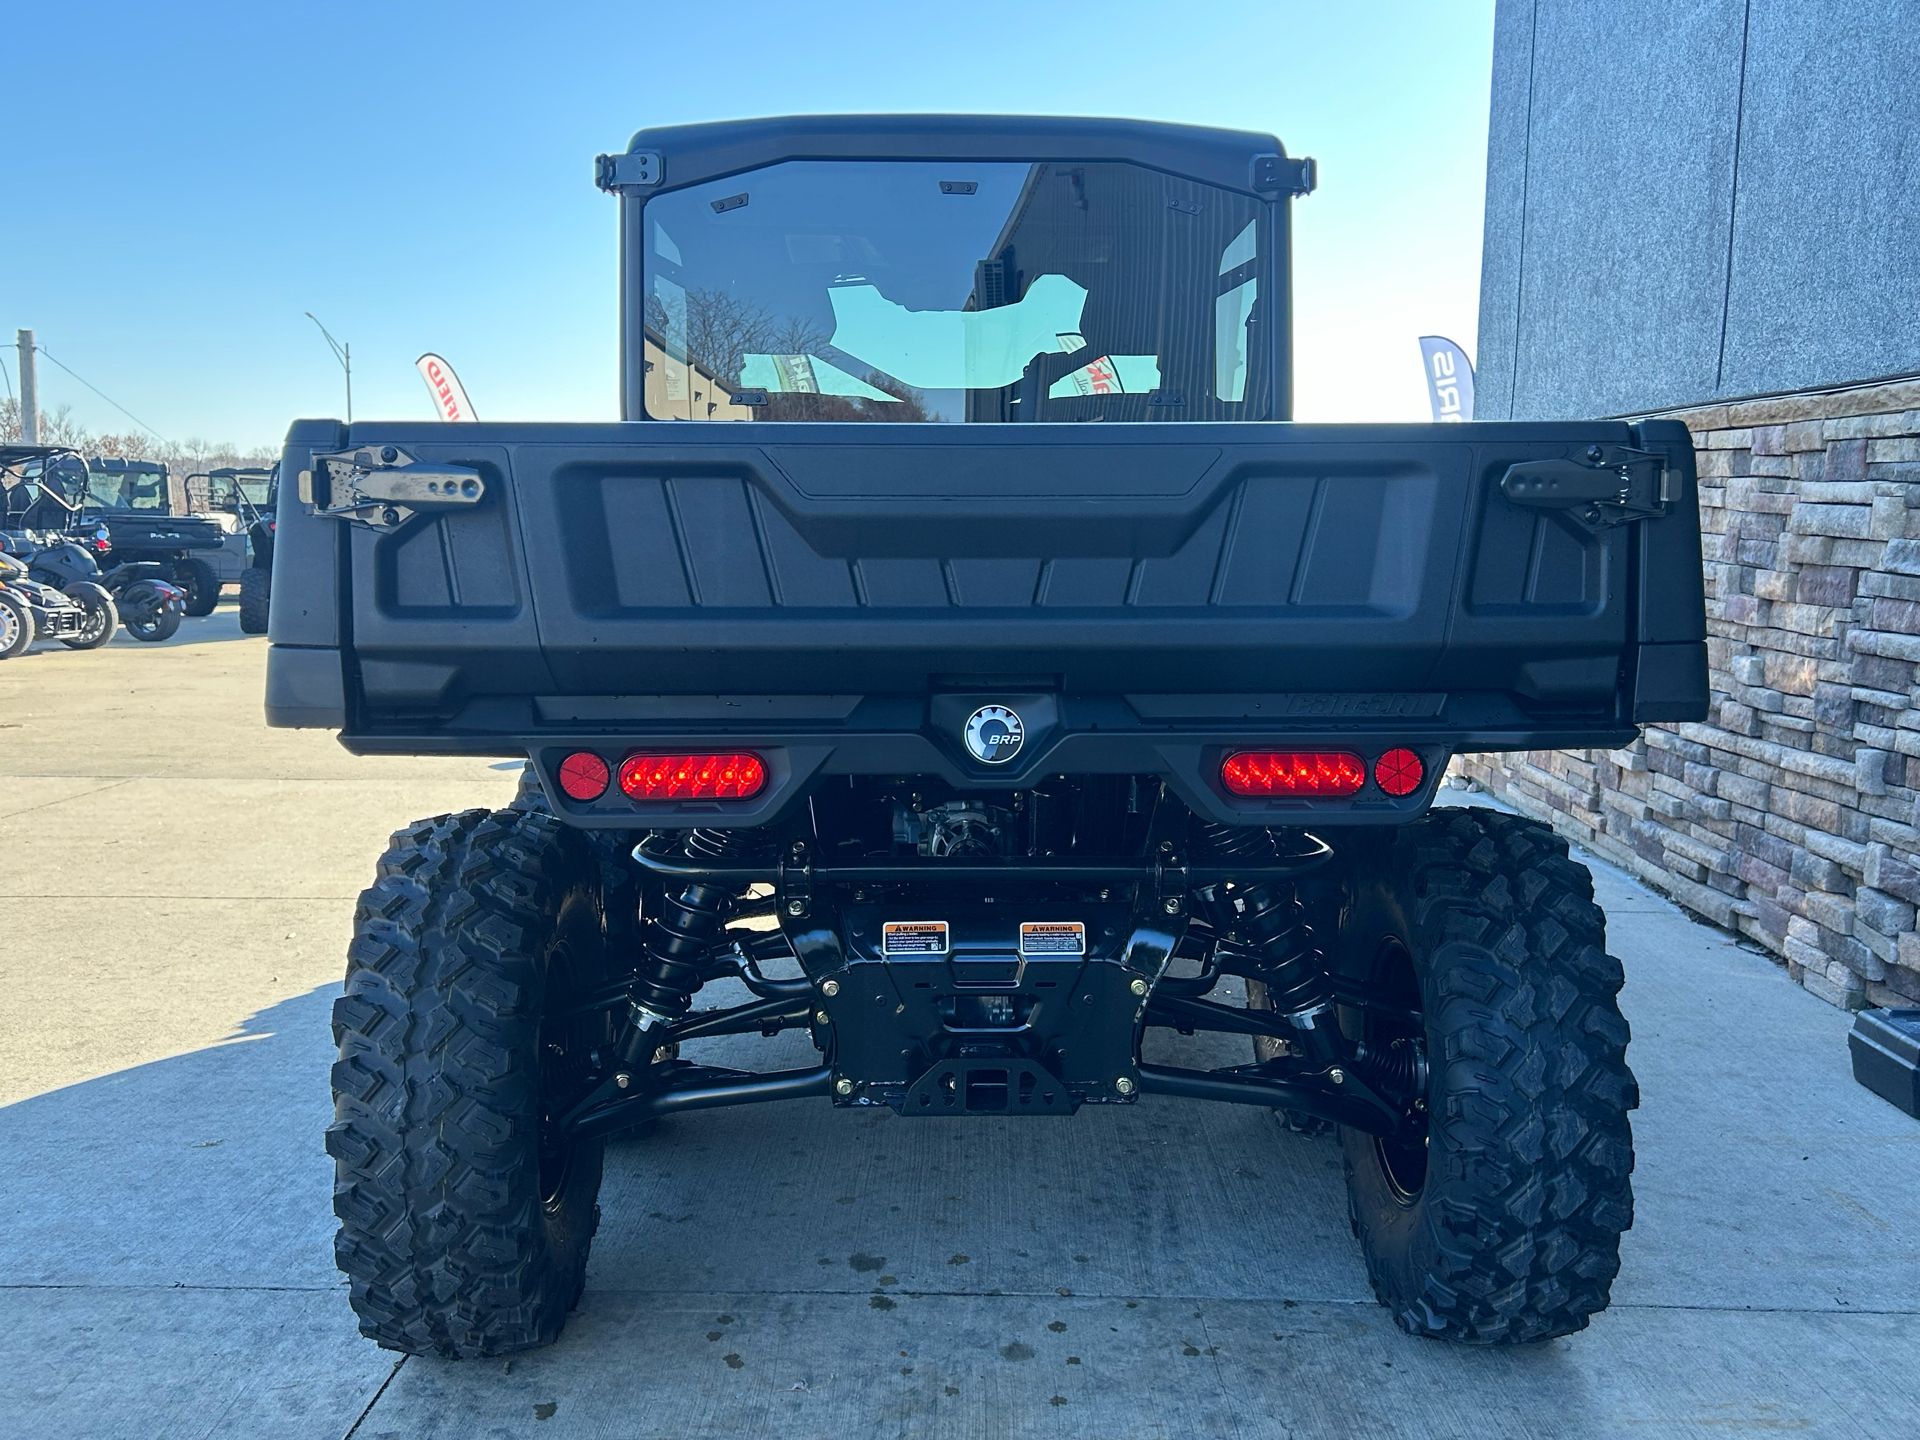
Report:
326,810,611,1357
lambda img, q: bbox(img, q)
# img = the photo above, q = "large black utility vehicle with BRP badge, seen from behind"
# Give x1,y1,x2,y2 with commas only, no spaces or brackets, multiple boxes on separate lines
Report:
267,117,1707,1356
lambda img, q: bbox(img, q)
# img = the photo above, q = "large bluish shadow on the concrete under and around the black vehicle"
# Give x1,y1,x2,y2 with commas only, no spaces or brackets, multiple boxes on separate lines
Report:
0,929,1920,1440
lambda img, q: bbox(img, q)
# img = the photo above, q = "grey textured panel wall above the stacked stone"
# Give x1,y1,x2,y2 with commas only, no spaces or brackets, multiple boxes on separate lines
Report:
1475,0,1920,420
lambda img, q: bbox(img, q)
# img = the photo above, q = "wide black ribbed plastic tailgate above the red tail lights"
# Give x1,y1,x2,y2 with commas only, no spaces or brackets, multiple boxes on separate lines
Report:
269,422,1705,779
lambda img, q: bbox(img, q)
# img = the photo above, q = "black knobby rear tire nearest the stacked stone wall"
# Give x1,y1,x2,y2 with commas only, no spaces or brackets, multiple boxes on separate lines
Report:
1340,808,1640,1344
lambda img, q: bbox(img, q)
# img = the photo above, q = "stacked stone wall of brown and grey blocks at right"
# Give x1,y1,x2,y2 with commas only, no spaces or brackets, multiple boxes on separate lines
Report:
1455,380,1920,1008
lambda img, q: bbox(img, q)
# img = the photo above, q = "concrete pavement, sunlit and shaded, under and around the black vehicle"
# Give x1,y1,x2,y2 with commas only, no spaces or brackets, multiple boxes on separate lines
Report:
0,609,1920,1440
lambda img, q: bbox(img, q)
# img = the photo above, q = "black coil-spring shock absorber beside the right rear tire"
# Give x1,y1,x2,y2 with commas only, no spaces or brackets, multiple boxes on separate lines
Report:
1200,822,1348,1066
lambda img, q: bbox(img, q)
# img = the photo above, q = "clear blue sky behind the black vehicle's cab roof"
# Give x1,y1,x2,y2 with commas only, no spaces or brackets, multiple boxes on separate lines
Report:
0,0,1492,445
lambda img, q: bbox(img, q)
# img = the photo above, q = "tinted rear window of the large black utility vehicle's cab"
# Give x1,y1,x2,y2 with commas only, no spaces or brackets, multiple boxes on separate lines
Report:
637,161,1273,422
